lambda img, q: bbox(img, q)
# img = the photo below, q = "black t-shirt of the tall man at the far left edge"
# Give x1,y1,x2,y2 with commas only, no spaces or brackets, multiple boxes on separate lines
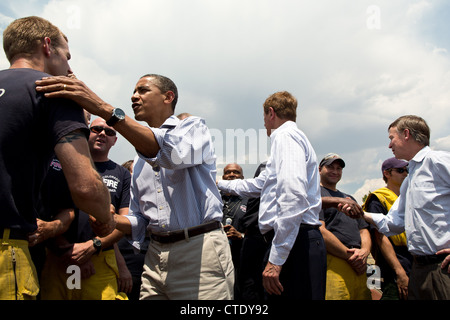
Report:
0,69,89,233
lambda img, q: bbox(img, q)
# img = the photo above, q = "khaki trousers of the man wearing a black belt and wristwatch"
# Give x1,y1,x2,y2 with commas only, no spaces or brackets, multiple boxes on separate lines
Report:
140,228,234,300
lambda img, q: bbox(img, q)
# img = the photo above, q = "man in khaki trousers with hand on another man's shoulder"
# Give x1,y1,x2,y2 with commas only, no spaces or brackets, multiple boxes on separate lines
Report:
39,74,234,300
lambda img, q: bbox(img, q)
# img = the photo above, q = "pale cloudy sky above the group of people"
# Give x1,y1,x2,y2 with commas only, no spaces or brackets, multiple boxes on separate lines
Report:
0,0,450,201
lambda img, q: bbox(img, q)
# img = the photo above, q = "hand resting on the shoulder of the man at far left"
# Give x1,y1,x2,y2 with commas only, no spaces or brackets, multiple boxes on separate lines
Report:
36,76,106,116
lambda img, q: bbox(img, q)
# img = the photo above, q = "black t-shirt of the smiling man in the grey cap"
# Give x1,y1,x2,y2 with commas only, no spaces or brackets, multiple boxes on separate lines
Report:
319,187,369,248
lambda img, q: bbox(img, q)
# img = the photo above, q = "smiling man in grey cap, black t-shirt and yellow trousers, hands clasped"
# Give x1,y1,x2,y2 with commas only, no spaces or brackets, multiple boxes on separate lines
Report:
319,153,371,300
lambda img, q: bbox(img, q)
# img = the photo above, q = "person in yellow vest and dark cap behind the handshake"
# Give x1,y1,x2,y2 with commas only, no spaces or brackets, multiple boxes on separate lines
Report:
363,157,412,300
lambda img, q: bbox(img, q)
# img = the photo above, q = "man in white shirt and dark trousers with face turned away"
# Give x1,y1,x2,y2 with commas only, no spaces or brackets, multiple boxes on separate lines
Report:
218,92,326,300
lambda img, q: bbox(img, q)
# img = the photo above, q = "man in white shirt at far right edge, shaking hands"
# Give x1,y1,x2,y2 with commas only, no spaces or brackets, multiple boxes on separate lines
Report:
356,115,450,300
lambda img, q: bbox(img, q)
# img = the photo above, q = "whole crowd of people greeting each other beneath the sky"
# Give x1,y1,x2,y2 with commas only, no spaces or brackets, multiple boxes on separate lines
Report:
0,17,450,301
